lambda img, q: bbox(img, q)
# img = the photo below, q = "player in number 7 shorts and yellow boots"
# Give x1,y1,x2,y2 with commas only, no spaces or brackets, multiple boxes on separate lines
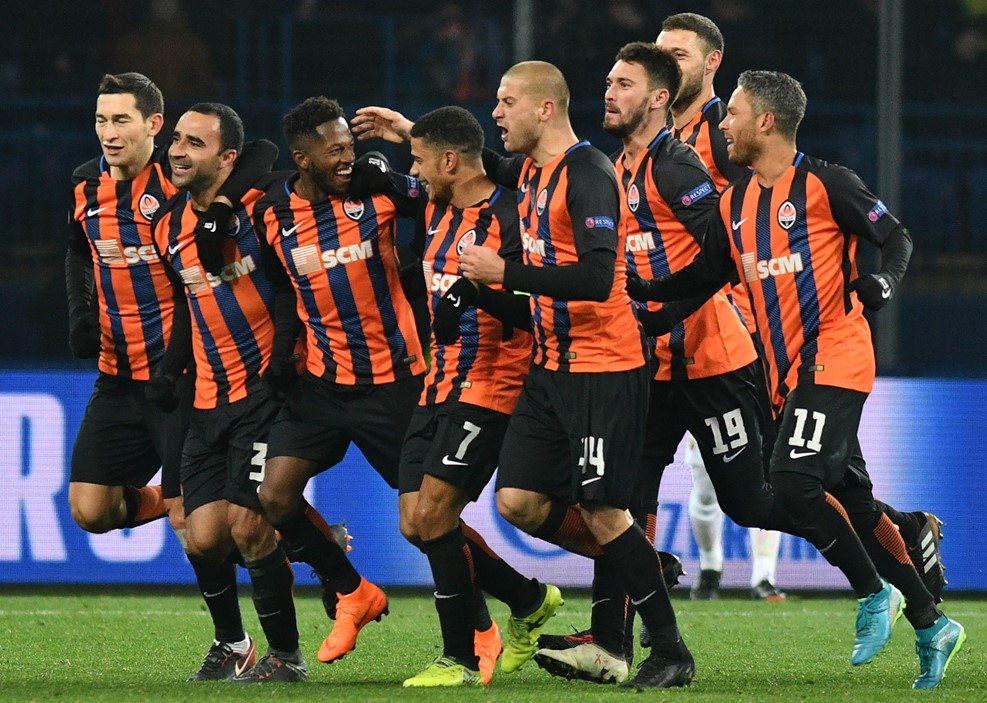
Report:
384,107,558,687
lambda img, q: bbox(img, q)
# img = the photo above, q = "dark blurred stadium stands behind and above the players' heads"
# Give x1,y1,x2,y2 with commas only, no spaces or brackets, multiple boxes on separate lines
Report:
0,0,987,376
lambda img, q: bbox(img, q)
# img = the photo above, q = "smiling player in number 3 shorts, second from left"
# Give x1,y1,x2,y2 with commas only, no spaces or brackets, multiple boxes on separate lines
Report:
152,103,308,683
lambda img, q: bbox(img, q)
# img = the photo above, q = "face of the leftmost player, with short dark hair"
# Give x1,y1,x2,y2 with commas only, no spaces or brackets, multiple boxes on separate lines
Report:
96,93,157,175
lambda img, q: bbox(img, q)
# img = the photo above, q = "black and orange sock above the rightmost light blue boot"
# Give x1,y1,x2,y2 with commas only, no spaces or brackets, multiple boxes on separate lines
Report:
850,506,942,630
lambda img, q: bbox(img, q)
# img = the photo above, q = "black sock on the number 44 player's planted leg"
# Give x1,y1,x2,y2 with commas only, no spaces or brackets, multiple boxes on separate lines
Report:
603,524,679,654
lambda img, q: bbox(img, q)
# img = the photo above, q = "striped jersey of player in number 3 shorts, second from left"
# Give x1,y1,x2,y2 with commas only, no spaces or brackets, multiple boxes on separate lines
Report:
154,183,283,409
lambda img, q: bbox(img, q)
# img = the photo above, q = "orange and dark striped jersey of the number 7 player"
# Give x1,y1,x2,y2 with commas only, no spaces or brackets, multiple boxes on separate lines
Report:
420,186,531,415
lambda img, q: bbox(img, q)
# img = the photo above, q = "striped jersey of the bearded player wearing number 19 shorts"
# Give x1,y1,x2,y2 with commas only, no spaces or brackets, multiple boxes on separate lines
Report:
616,130,757,381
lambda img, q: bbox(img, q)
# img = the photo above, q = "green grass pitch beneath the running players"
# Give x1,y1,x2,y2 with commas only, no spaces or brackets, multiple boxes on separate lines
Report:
0,588,987,703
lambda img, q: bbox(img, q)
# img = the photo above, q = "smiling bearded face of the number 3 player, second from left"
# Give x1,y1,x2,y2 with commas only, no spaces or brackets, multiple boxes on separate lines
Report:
168,112,232,195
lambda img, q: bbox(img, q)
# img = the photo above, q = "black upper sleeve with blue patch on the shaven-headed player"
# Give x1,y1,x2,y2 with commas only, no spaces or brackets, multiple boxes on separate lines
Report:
566,152,620,256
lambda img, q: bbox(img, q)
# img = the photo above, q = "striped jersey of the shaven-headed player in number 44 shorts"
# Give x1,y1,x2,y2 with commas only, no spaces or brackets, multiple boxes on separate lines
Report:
517,141,648,373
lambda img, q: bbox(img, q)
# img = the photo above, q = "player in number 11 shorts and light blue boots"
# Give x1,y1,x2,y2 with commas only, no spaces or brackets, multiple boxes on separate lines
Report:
632,71,966,688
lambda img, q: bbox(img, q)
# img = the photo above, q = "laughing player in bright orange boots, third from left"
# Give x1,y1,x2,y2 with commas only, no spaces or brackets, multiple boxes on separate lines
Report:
255,97,425,663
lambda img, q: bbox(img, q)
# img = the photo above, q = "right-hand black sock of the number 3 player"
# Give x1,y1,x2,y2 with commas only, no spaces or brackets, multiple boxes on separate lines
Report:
247,547,298,654
